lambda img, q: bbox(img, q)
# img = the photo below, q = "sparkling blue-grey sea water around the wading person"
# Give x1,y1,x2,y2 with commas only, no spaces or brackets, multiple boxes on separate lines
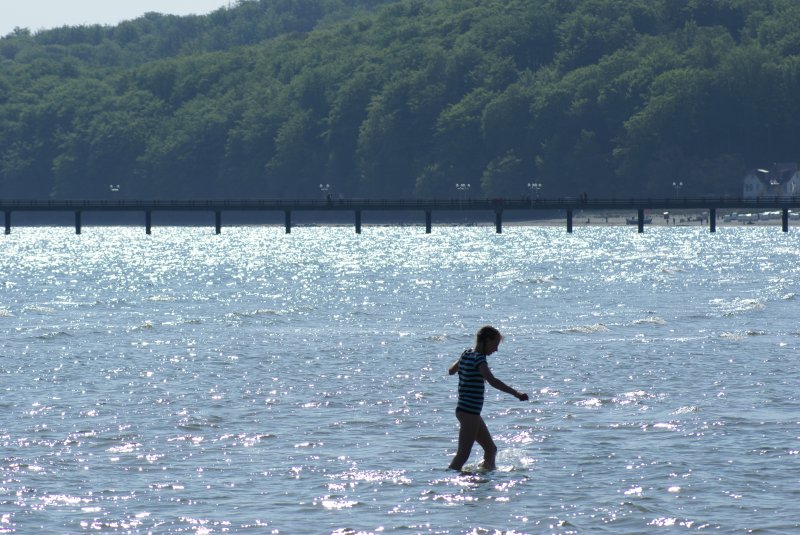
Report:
0,226,800,534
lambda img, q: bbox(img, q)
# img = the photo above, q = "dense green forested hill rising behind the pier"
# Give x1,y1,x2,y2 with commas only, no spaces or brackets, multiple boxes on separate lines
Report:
0,0,800,199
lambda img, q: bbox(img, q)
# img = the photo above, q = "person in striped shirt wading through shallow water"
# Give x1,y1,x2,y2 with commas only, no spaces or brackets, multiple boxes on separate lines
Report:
449,325,528,470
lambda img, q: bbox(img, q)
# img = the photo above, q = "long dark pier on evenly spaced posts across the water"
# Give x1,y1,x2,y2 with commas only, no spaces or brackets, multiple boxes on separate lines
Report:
0,197,800,234
